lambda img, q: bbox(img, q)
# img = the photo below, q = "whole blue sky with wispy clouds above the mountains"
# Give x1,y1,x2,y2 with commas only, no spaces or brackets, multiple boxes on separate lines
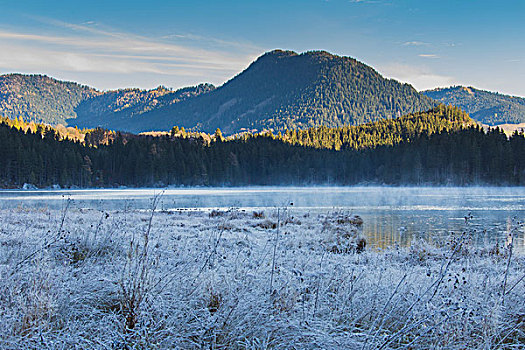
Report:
0,0,525,96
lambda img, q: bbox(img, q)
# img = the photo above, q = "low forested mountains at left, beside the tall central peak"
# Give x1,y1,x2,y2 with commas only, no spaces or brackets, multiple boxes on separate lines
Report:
0,74,215,129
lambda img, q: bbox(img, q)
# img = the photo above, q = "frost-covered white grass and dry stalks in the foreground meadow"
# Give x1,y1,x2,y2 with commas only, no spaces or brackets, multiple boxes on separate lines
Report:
0,204,525,349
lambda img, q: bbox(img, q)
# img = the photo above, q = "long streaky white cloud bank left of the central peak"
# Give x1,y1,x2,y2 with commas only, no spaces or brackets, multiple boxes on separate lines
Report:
0,20,262,89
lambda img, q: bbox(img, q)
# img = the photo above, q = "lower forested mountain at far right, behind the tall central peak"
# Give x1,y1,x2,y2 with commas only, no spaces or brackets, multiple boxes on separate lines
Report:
422,86,525,126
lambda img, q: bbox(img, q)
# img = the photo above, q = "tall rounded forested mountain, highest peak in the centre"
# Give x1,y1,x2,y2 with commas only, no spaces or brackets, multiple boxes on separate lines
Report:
112,50,435,133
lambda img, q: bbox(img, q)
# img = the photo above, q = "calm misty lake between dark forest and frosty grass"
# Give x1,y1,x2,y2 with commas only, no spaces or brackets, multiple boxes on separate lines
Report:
0,187,525,254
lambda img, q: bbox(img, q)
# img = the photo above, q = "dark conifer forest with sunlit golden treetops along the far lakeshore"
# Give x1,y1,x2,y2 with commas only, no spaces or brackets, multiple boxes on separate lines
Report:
0,106,525,188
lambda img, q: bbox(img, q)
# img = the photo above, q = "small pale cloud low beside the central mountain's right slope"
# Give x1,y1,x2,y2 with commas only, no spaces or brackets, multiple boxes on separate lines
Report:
378,64,456,90
